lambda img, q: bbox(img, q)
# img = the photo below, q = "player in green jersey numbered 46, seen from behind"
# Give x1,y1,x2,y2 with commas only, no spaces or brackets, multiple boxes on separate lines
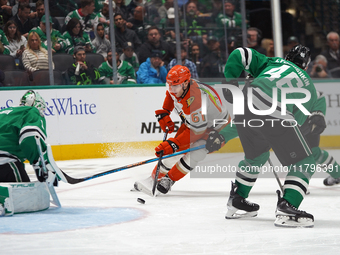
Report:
209,45,326,227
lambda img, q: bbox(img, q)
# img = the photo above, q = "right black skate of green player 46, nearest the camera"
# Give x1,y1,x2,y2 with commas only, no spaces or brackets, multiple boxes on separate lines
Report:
274,190,314,228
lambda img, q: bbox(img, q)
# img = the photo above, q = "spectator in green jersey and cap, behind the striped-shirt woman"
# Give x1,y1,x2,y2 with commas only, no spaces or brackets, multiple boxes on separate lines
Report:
30,15,68,53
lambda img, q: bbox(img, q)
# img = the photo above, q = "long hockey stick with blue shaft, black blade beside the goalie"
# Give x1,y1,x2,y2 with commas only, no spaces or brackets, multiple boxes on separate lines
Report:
55,144,205,184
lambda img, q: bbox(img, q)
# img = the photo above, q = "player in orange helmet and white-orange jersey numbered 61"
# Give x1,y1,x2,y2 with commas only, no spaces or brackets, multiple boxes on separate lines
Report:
135,65,230,195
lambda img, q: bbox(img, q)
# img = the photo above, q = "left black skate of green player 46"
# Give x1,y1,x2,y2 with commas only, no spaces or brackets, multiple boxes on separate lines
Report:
225,182,260,219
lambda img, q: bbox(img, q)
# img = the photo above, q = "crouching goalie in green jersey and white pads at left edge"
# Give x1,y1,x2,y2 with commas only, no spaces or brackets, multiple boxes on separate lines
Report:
0,90,59,216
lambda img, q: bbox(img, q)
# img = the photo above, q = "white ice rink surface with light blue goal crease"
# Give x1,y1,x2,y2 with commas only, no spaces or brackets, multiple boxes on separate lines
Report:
0,150,340,255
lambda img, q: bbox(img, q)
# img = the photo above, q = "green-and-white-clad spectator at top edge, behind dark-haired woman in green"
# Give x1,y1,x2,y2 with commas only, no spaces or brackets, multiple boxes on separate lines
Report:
65,0,96,38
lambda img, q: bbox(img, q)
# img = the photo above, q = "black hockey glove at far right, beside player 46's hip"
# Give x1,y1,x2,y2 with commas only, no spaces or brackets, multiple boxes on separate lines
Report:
301,111,326,135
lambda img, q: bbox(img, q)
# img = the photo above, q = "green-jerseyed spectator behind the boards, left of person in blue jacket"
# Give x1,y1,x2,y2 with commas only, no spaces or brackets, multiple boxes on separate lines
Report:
98,48,136,84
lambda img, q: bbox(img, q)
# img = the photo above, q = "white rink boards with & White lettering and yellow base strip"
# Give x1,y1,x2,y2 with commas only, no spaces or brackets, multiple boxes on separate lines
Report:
0,82,340,160
